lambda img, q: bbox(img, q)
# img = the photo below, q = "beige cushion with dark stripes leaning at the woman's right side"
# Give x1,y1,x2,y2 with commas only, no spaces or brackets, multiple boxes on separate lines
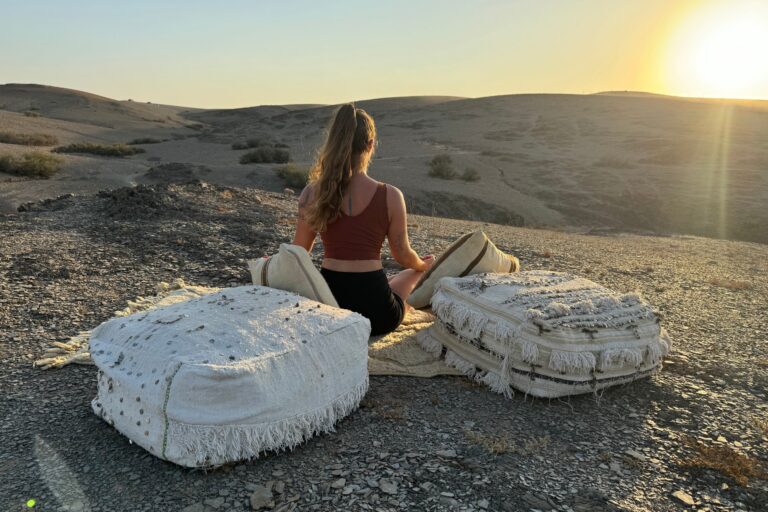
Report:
408,231,520,309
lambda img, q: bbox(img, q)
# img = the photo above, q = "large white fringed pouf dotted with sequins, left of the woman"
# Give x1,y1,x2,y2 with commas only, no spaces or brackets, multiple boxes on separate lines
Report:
90,286,370,467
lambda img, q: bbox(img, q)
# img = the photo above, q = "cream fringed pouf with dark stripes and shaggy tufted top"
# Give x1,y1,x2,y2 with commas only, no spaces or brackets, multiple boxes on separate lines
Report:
420,270,670,397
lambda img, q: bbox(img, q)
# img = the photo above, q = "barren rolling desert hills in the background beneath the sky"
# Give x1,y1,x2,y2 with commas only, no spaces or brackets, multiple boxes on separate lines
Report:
0,85,768,243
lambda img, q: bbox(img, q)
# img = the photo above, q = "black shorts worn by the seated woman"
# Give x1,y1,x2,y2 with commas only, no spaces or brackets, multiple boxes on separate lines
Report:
320,268,405,336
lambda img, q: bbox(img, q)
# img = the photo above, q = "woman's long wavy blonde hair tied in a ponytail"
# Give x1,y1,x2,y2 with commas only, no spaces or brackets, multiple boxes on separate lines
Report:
306,103,376,232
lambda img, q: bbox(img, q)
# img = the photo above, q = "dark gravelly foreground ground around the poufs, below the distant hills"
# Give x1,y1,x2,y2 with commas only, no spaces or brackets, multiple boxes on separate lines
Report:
0,183,768,512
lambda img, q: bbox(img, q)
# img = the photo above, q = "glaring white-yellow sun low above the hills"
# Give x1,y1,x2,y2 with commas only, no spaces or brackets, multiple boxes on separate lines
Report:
665,2,768,98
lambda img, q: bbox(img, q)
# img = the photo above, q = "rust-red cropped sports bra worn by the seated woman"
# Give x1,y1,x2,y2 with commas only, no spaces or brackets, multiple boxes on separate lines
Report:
320,183,389,260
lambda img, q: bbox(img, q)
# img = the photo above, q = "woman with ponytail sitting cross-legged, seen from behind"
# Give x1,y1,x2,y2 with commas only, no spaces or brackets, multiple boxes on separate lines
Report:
293,104,434,335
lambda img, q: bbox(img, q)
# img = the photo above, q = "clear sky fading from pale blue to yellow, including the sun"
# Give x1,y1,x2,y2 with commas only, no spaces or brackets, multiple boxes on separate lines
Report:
0,0,768,108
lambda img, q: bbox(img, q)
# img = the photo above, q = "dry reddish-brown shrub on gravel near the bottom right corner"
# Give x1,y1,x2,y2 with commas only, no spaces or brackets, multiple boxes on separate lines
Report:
682,437,768,487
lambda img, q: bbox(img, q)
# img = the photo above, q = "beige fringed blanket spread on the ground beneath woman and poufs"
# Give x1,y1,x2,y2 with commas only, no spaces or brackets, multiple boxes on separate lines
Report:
34,279,461,378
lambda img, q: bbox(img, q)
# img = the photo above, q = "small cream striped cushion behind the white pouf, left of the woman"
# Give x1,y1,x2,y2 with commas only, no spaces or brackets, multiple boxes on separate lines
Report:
248,244,339,307
